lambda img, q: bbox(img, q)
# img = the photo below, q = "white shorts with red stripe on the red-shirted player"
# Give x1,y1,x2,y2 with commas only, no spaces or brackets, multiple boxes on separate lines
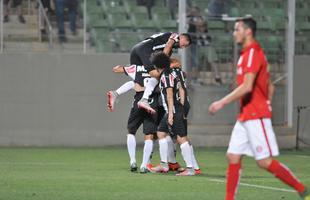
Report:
227,118,279,160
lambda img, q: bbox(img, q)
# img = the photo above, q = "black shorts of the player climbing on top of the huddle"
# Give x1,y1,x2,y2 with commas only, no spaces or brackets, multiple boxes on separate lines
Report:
130,42,155,72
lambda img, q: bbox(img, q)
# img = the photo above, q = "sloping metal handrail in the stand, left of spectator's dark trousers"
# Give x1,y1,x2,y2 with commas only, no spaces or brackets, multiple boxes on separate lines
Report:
37,0,53,48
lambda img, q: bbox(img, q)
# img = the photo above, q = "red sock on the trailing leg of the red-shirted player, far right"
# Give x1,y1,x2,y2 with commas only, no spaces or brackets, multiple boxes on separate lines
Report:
268,160,305,193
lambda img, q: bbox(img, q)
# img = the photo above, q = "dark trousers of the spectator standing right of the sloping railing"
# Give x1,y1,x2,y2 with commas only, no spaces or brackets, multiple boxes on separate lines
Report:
55,0,78,43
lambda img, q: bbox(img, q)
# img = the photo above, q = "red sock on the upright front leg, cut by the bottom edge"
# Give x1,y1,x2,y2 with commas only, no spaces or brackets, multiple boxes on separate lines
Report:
226,163,241,200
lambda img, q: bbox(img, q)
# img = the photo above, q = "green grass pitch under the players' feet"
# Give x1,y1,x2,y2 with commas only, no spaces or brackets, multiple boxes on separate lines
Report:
0,147,310,200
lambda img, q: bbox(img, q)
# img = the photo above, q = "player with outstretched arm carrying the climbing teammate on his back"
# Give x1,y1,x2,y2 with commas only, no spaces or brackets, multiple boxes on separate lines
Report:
113,65,159,173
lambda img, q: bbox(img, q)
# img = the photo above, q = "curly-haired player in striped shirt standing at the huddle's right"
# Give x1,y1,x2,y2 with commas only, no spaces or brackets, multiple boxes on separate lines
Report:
150,52,200,176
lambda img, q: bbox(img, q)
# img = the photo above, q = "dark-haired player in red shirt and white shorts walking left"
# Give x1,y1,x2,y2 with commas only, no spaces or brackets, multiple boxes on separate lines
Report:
209,18,310,200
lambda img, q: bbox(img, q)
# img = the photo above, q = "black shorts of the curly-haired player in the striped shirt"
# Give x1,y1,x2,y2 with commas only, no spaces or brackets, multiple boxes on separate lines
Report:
157,104,187,137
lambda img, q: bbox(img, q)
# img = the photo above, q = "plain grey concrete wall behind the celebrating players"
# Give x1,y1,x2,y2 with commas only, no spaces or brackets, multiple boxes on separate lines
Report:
0,53,302,148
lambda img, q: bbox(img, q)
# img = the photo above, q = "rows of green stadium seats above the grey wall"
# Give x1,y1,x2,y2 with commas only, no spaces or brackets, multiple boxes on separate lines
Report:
83,0,310,83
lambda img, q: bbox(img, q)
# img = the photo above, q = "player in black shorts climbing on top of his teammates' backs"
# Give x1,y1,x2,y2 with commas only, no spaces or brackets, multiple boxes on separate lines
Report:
107,32,191,113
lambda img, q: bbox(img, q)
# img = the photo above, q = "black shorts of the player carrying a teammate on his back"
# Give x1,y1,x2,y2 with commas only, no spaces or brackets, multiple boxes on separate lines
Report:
127,92,158,135
